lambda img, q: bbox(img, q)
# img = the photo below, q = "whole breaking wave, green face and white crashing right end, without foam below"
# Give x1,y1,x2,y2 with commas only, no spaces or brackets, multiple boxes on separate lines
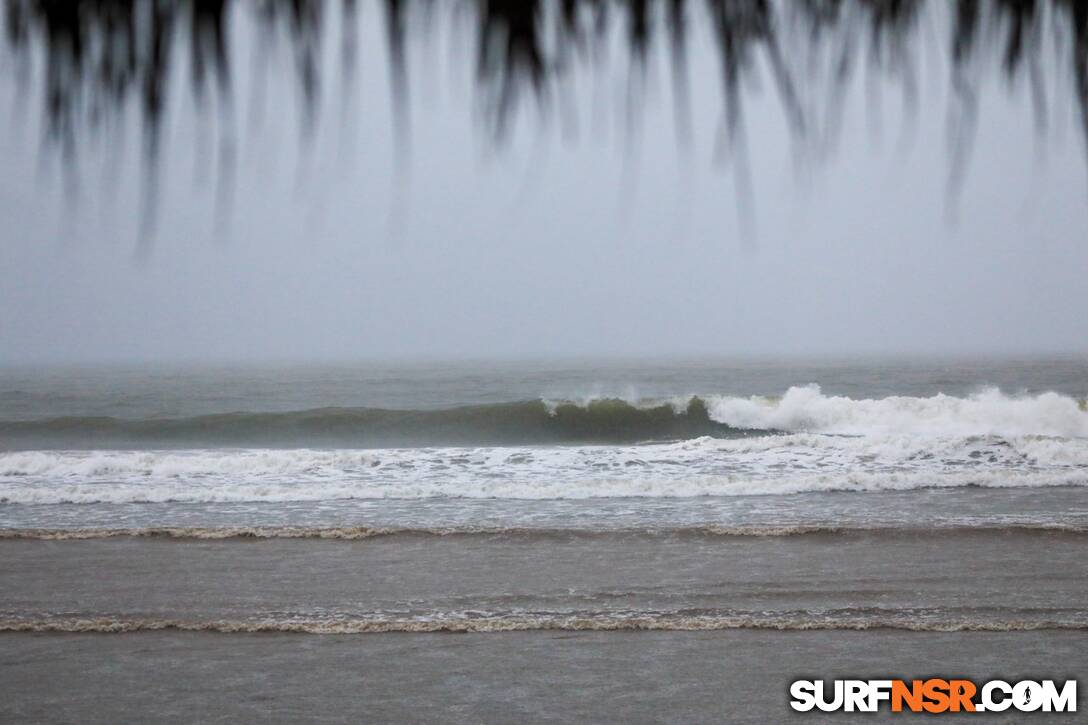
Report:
0,385,1088,450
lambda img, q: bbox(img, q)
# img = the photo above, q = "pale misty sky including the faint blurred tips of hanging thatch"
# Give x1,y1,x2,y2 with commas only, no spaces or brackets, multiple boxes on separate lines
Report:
0,2,1088,365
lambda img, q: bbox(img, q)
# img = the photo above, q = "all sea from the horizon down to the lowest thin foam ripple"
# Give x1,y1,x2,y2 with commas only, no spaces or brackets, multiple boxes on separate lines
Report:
0,359,1088,631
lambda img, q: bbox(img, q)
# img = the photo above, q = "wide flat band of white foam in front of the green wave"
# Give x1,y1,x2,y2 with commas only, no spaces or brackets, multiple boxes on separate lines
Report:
0,433,1088,503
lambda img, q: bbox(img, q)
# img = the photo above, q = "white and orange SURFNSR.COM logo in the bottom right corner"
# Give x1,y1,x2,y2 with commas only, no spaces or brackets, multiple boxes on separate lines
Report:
790,678,1077,713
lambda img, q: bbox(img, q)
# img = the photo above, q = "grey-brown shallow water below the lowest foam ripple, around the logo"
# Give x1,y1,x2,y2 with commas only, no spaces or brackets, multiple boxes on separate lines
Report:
0,630,1088,725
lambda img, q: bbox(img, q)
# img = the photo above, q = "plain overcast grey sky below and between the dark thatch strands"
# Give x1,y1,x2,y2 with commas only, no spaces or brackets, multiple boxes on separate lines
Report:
0,2,1088,364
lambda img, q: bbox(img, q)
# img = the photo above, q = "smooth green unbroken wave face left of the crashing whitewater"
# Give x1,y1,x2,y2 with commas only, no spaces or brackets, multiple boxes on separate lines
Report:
0,397,745,447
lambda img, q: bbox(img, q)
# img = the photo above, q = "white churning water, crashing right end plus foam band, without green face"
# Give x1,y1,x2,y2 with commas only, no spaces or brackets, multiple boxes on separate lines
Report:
0,384,1088,504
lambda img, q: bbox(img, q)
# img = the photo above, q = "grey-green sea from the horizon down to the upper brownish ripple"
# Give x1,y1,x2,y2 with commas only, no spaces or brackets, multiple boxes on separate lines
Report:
0,359,1088,536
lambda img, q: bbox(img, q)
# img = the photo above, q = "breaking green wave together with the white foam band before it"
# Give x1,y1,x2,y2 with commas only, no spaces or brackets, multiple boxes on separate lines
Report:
0,385,1088,504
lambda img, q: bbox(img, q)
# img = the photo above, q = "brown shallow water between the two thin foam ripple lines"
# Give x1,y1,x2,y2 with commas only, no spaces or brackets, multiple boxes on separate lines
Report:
0,527,1088,632
